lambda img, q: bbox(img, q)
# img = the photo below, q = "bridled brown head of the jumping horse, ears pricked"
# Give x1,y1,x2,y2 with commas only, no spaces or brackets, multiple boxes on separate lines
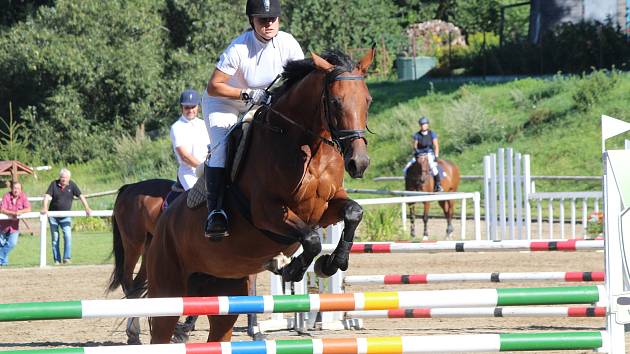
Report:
313,49,375,178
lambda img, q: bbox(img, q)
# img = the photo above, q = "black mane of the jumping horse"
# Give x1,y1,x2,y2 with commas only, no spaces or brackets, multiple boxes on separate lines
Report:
272,50,355,99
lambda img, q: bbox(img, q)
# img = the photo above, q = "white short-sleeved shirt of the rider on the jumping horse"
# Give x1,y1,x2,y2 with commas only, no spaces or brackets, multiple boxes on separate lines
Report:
203,30,304,117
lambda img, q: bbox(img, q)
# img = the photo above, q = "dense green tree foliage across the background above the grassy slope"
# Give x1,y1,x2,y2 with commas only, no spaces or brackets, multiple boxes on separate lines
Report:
0,0,627,163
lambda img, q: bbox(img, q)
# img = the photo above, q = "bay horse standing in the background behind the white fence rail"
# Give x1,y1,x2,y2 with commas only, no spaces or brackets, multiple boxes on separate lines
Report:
405,154,460,240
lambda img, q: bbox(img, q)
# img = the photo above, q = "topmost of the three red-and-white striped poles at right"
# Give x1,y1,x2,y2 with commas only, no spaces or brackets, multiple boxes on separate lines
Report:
322,240,604,253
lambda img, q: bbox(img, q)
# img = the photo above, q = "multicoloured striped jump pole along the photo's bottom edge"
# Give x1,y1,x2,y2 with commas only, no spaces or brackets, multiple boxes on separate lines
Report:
2,332,606,354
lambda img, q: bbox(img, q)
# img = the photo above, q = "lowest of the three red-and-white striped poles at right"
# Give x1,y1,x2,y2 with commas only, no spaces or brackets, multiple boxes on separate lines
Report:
346,306,606,318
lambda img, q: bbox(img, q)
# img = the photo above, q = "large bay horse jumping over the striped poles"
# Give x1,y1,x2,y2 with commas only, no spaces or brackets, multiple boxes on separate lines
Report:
147,49,374,343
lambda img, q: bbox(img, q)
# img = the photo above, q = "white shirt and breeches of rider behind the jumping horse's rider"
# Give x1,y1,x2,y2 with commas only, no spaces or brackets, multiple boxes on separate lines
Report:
171,116,210,190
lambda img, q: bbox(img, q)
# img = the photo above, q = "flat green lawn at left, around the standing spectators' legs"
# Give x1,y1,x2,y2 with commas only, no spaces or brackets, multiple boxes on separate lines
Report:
4,231,113,267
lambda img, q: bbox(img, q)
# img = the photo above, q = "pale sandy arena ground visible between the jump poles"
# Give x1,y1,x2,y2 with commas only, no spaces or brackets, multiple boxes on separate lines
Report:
0,252,630,353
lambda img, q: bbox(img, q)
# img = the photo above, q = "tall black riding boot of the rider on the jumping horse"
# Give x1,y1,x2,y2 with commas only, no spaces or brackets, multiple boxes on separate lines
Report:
204,165,229,241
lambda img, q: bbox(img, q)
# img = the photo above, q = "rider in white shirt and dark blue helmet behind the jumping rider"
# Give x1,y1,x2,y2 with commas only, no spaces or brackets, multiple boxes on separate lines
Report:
171,89,210,190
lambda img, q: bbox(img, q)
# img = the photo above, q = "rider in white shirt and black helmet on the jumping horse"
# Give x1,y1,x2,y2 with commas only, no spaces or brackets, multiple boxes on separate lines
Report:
202,0,304,241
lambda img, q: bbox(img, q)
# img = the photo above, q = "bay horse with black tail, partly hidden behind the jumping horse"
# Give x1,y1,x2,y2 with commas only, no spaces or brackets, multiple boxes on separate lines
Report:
107,179,260,344
